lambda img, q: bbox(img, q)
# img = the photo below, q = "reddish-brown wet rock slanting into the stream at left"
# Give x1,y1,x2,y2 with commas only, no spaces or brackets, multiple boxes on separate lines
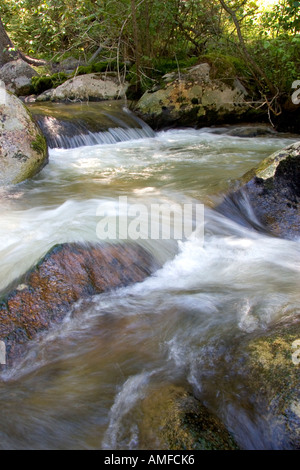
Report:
0,243,157,364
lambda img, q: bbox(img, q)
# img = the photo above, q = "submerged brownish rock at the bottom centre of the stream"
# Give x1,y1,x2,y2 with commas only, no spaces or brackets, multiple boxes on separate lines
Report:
141,385,238,450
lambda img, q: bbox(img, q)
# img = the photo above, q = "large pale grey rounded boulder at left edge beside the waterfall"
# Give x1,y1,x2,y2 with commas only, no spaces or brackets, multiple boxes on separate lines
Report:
0,88,48,185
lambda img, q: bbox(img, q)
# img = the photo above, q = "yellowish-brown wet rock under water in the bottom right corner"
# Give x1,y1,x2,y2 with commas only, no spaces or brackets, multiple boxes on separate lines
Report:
230,315,300,450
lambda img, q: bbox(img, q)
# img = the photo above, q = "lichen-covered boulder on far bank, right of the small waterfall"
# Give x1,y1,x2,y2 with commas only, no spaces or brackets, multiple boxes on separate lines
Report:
135,63,253,129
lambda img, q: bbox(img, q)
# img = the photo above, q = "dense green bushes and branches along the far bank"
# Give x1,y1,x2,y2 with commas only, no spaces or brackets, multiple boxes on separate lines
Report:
0,0,300,105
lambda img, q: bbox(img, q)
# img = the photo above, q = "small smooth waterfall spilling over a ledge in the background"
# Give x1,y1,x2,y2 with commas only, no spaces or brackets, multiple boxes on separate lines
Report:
31,103,155,149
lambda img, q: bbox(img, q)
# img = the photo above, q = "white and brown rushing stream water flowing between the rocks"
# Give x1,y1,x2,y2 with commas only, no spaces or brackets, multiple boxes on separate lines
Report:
0,103,300,449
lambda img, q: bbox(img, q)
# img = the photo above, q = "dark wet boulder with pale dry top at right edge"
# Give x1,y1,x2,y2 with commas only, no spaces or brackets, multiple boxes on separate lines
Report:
218,142,300,239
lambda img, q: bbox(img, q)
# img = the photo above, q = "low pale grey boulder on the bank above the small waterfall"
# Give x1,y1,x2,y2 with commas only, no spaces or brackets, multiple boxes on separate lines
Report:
37,73,128,101
